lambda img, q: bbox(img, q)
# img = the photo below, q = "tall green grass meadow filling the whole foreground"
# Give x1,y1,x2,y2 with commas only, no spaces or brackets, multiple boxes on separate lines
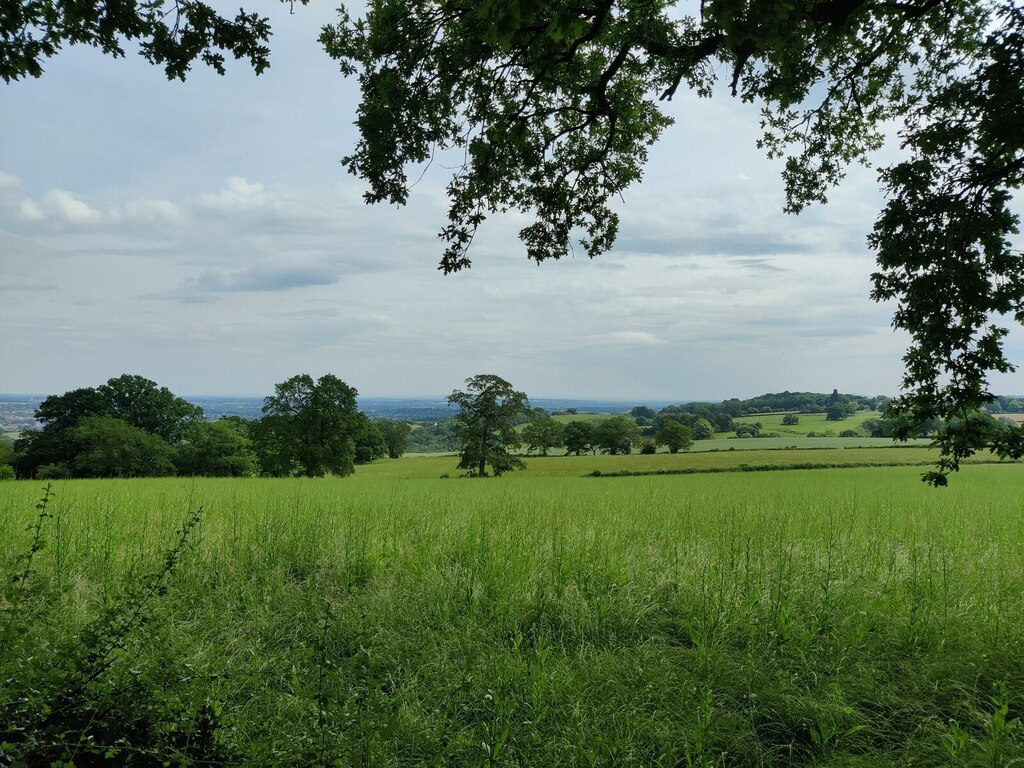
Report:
0,460,1024,766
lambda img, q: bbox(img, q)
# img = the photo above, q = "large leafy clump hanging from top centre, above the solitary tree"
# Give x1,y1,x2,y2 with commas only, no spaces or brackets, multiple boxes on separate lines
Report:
321,0,670,272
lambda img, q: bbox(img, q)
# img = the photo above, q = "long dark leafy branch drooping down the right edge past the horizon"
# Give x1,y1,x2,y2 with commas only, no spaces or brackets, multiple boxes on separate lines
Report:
869,7,1024,485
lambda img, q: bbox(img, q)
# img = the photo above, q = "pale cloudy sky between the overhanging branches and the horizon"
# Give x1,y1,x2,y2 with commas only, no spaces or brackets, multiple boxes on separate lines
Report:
0,3,1024,402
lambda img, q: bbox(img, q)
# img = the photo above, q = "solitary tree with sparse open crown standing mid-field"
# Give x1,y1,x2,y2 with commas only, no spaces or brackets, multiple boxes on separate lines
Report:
447,374,529,477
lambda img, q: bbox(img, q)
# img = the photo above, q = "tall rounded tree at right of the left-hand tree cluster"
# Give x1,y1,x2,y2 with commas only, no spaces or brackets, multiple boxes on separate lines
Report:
260,374,366,477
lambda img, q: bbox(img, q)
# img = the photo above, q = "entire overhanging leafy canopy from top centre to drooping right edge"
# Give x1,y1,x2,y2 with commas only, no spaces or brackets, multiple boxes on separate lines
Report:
322,0,1024,484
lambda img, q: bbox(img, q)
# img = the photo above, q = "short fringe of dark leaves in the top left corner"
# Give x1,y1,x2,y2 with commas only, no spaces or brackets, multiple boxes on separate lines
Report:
0,0,308,82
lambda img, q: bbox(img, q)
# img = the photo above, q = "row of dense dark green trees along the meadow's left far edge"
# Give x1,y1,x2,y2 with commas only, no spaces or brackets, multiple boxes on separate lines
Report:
6,374,411,479
